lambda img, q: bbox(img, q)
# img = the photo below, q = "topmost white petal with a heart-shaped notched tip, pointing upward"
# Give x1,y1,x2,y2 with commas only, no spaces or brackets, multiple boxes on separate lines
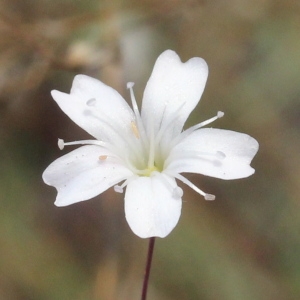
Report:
142,50,208,136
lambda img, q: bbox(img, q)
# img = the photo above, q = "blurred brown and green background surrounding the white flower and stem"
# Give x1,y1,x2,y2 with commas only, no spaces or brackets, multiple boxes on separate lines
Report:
0,0,300,300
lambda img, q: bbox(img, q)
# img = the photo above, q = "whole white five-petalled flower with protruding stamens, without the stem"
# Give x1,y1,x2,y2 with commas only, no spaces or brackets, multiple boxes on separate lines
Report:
43,50,258,238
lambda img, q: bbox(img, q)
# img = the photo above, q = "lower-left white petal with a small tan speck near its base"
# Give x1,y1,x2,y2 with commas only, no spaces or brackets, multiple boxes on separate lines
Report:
43,146,132,206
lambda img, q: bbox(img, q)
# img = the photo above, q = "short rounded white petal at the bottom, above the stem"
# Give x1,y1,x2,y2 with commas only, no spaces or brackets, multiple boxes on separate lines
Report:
125,173,182,238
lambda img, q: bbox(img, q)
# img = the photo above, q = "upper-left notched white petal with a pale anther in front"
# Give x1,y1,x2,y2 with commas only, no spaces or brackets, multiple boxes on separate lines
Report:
51,75,134,143
